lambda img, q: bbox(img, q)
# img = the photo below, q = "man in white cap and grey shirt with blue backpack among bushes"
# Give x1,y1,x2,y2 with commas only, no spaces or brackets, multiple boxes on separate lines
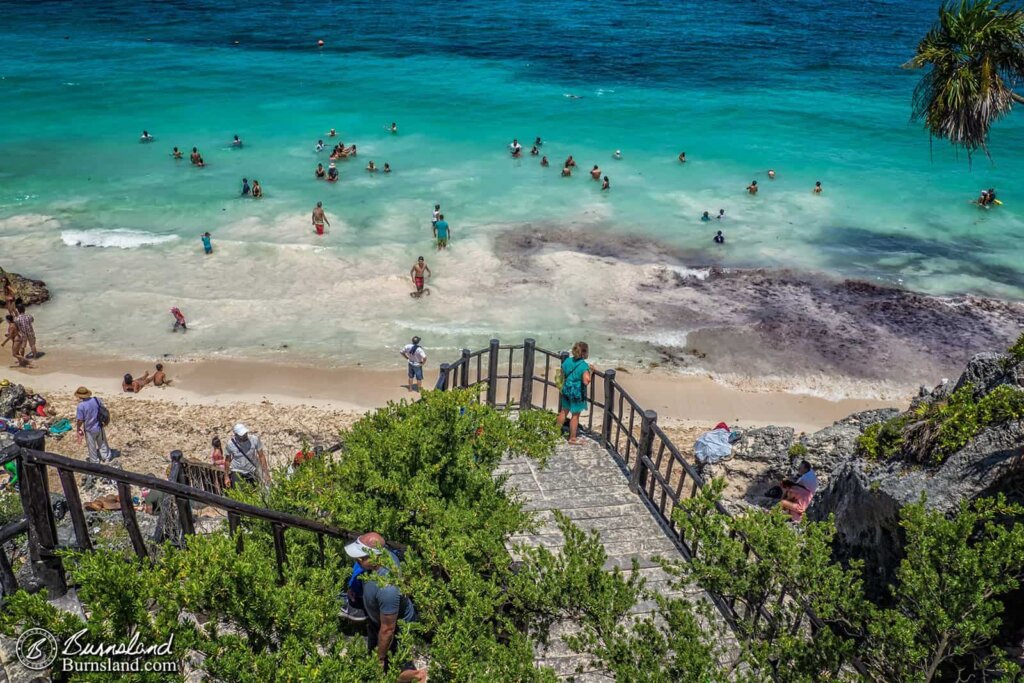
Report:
345,531,427,682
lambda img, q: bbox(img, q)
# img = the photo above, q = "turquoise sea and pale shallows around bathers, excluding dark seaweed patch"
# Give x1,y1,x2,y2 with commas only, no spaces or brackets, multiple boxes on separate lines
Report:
0,0,1024,374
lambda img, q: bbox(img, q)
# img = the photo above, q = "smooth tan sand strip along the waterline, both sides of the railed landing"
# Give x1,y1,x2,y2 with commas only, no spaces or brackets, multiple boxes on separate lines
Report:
0,348,909,430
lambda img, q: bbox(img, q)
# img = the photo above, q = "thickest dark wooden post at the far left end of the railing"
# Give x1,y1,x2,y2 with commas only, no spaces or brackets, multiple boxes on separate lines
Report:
14,430,68,598
